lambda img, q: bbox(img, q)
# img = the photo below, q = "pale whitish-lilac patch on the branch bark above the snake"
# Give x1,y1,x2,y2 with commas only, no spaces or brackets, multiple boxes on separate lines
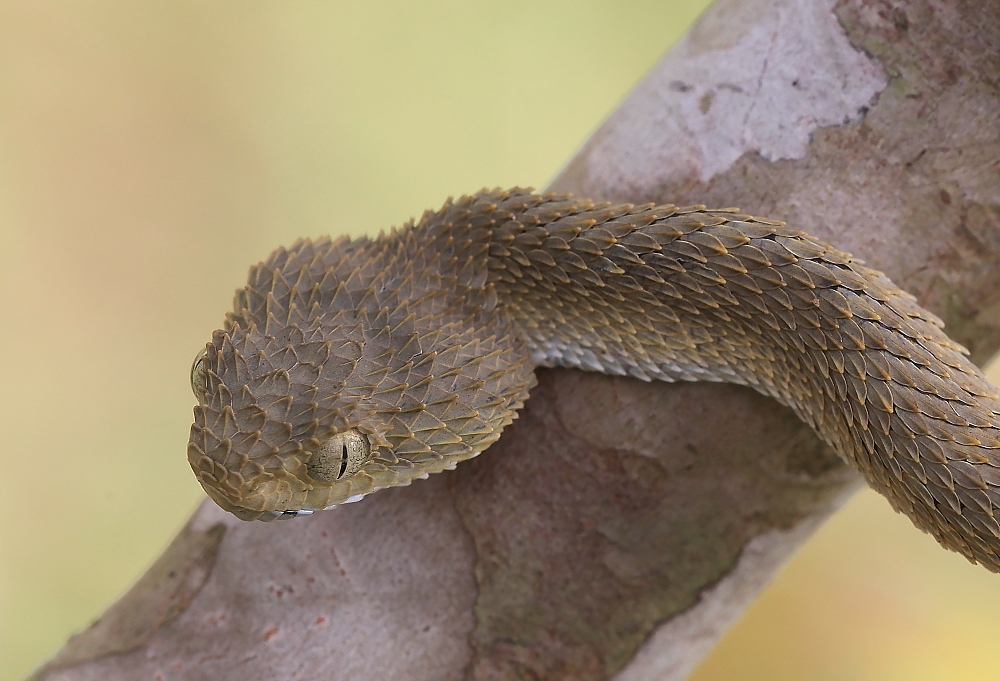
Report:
563,0,886,194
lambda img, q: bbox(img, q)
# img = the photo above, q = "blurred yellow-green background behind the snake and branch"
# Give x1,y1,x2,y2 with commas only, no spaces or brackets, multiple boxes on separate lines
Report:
0,0,1000,681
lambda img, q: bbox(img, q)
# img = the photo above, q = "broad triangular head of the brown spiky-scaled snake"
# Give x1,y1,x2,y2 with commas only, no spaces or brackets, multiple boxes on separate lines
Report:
188,234,534,520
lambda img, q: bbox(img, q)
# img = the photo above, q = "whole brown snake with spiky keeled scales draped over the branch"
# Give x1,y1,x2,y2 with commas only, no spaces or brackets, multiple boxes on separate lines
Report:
187,188,1000,572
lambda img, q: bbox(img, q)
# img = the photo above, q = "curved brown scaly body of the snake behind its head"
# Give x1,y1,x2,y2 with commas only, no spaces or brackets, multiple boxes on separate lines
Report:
440,186,1000,571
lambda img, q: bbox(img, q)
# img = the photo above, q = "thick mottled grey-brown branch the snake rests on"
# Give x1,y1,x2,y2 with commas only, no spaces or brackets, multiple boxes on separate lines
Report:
34,0,1000,681
